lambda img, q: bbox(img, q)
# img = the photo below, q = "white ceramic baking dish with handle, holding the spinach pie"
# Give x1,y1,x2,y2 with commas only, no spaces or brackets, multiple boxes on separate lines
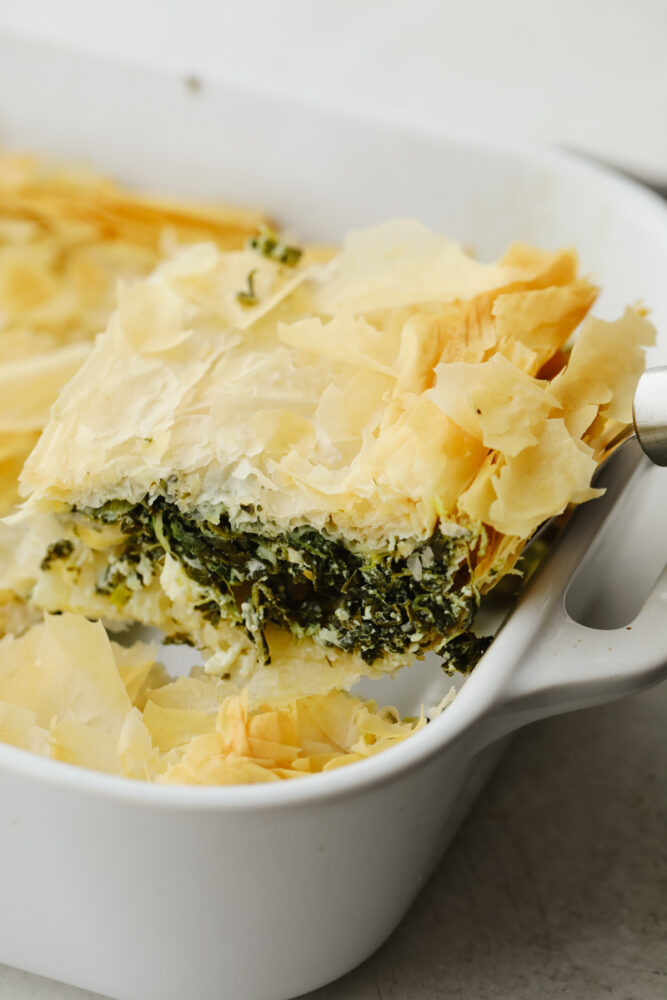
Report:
0,23,667,1000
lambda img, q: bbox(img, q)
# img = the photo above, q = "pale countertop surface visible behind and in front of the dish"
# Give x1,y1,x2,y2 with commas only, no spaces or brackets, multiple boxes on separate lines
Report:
0,0,667,1000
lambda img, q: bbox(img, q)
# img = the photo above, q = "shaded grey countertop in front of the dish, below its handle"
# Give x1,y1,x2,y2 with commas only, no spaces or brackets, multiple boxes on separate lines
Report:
0,685,667,1000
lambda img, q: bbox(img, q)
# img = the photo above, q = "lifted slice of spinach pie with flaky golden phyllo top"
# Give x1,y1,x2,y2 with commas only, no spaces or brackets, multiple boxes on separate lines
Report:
7,221,654,693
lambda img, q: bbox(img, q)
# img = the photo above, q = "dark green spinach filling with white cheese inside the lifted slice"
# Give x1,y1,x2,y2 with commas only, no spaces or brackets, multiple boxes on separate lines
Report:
68,498,484,671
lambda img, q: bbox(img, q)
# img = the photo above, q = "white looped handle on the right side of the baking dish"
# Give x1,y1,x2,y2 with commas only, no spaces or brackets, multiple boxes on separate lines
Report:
473,441,667,743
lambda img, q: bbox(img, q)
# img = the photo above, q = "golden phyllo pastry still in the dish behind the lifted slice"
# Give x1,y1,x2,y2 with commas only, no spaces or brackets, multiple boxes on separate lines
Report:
0,154,264,520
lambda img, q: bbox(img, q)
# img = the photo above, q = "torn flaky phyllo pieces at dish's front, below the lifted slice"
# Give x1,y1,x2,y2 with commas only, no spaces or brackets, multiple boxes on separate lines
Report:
0,614,426,785
